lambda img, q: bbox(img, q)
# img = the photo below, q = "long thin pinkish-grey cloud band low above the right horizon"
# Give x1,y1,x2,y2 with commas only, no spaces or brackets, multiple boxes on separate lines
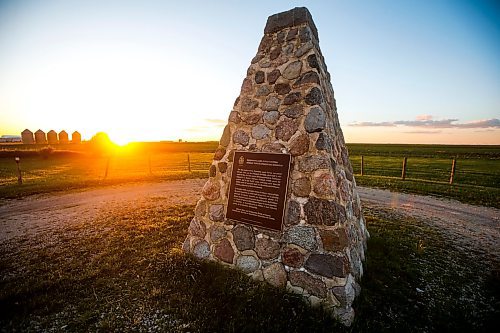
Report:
349,115,500,129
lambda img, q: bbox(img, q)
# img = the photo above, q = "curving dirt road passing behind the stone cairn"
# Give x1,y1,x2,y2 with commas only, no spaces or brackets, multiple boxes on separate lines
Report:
0,179,500,261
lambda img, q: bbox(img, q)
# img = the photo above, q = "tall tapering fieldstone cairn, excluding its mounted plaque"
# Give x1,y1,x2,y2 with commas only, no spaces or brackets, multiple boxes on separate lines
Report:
183,8,368,325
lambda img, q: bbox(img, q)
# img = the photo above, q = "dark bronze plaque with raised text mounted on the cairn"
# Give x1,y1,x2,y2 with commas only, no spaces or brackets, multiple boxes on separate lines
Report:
226,151,290,231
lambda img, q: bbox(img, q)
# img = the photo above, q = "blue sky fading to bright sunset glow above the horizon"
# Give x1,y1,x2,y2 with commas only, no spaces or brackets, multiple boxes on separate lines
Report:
0,0,500,144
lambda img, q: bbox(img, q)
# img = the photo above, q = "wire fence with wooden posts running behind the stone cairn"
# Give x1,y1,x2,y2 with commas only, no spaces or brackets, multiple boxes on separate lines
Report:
0,152,500,188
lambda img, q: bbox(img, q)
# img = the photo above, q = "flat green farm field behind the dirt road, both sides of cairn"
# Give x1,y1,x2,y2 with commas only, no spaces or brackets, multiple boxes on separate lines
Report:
0,142,500,207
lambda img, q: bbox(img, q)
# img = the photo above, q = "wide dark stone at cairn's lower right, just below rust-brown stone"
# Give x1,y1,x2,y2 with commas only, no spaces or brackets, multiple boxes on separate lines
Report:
304,253,349,278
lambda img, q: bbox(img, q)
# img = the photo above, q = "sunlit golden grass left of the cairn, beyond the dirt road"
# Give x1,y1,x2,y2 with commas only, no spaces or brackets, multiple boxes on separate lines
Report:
0,152,213,198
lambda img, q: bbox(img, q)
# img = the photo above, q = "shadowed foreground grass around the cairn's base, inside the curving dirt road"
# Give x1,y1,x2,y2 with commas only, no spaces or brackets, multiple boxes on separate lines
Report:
0,199,500,332
